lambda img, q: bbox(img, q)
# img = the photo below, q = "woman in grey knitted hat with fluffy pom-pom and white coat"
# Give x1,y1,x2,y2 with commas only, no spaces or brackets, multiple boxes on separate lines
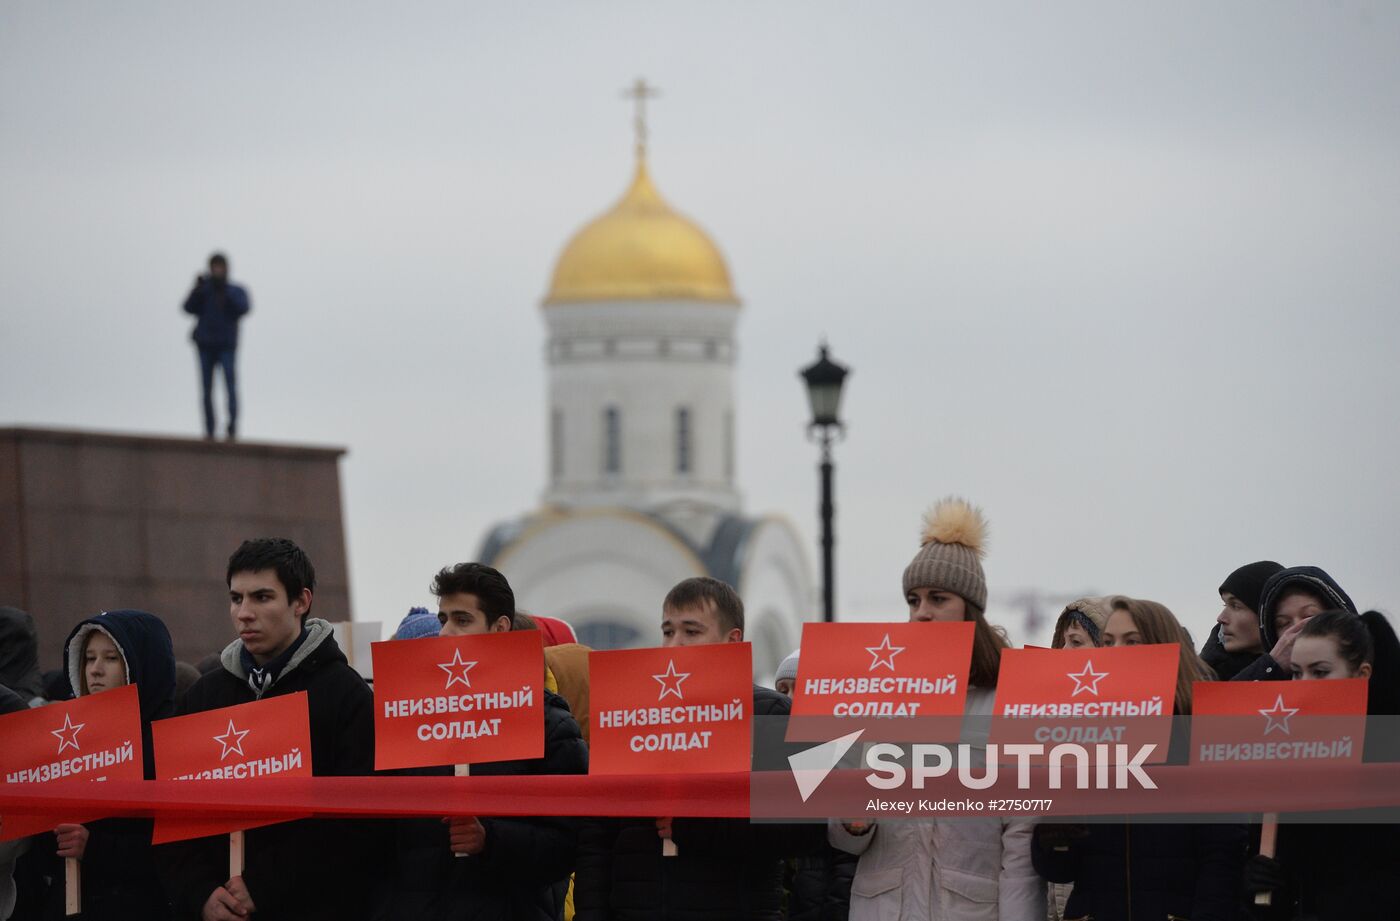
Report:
827,498,1046,921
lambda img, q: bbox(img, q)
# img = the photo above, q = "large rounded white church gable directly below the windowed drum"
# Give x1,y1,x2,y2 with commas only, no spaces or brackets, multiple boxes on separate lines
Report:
496,509,704,647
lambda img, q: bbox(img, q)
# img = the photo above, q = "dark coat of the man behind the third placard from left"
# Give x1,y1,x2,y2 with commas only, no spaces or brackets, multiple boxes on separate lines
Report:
374,691,588,921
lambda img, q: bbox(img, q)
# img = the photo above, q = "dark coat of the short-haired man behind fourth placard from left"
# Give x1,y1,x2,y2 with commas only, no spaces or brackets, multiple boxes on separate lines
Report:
574,687,825,921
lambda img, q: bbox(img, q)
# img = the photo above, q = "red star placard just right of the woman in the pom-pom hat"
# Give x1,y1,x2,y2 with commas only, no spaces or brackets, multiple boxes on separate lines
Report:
991,642,1182,761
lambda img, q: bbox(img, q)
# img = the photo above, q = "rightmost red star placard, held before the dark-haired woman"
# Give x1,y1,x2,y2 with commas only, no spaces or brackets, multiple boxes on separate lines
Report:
1191,677,1369,764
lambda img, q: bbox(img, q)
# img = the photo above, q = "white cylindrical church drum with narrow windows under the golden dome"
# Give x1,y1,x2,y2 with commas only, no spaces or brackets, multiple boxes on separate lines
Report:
545,301,739,511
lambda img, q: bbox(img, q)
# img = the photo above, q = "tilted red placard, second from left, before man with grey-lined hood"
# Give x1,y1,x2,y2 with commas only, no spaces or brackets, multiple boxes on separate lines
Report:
151,691,311,844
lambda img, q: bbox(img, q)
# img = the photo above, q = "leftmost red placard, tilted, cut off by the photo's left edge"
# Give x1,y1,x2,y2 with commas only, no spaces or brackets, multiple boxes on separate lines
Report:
0,684,144,841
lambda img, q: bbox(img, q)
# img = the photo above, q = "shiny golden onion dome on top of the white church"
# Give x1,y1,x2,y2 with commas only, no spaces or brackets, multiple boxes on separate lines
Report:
545,157,739,307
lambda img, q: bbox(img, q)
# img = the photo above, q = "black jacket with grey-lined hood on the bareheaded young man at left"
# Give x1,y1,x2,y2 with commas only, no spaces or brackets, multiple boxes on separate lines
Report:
158,617,382,921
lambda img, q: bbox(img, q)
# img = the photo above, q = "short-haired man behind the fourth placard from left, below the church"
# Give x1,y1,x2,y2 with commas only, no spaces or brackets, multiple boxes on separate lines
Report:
574,577,826,921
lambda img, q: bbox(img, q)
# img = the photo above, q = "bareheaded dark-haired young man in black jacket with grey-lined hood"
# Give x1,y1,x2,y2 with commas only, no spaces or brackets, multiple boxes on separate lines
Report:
161,537,375,921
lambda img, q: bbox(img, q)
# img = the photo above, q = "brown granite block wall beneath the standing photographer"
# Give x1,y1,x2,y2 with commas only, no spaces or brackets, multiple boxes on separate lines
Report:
0,428,351,670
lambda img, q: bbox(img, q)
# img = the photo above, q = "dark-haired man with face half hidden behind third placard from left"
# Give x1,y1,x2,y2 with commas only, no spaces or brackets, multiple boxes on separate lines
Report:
374,563,588,921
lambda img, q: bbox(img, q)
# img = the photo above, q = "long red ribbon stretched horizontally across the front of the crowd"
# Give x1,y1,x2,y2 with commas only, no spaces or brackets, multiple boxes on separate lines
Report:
8,761,1400,823
